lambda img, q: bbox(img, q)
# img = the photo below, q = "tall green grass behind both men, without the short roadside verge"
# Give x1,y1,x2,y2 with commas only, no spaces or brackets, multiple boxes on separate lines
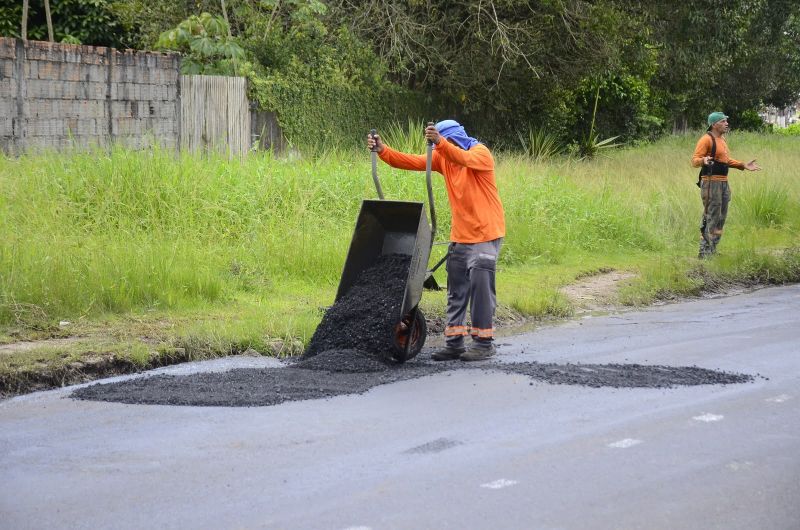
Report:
0,131,800,326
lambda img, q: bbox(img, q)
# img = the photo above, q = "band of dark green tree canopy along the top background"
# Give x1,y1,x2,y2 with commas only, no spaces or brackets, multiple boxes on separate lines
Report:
0,0,800,146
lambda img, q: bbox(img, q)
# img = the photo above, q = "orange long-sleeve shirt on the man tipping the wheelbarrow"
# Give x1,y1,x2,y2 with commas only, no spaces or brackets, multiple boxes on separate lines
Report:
380,138,506,243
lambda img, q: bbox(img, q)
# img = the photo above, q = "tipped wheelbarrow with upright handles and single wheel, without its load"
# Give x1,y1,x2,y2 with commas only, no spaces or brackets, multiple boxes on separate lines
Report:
336,129,444,363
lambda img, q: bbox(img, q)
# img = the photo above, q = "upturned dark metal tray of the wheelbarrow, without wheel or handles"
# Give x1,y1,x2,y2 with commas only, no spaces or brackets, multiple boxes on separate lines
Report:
336,200,432,322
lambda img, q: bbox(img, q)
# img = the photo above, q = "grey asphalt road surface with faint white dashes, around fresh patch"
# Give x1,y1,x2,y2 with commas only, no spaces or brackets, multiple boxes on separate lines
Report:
0,286,800,530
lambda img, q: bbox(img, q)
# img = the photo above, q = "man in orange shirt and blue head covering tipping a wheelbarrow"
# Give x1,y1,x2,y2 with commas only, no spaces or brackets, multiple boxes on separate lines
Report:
367,120,506,361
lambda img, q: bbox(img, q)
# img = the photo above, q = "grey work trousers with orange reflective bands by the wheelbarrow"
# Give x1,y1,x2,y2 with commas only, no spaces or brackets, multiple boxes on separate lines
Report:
444,237,503,348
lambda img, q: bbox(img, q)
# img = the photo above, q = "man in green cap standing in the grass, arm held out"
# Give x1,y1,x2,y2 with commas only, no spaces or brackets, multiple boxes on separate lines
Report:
692,112,761,258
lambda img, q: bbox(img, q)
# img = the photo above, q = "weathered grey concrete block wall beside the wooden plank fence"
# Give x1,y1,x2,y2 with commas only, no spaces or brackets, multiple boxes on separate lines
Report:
0,38,180,153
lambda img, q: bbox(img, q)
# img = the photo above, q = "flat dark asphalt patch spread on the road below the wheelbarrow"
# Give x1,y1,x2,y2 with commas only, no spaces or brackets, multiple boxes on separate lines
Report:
71,350,753,407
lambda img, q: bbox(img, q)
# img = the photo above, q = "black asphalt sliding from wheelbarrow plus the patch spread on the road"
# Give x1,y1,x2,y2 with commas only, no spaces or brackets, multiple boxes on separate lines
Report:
71,255,754,407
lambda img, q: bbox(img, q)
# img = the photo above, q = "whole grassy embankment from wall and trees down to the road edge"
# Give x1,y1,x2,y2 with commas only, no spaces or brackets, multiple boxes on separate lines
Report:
0,133,800,392
